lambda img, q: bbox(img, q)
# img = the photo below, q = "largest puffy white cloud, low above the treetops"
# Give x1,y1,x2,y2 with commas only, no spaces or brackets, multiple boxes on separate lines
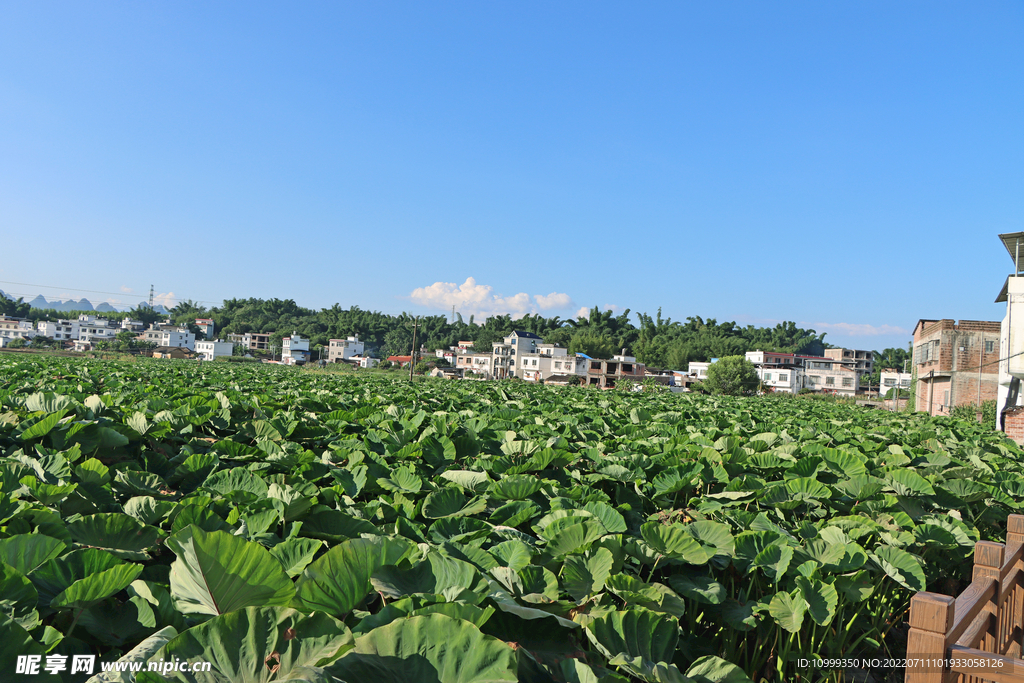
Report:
409,278,572,318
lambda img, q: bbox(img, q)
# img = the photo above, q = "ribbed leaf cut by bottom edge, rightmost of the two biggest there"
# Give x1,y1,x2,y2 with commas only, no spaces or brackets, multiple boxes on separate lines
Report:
328,613,518,683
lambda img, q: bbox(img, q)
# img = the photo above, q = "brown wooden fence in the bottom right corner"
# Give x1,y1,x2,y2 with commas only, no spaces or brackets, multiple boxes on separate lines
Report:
904,515,1024,683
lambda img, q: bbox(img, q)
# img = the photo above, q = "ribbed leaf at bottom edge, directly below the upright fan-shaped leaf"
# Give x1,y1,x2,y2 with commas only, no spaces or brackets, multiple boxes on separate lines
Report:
150,606,352,683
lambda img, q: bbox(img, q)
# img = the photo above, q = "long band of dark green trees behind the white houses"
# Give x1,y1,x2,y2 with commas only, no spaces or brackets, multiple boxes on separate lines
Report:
6,292,856,370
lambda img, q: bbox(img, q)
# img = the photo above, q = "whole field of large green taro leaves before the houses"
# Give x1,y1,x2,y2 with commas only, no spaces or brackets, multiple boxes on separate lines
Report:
0,354,1024,683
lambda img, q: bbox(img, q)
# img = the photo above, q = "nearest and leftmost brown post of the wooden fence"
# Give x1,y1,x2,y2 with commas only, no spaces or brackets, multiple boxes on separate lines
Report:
903,591,956,683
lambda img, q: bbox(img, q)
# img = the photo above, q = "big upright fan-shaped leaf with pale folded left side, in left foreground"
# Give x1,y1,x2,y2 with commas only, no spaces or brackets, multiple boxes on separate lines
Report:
167,526,295,615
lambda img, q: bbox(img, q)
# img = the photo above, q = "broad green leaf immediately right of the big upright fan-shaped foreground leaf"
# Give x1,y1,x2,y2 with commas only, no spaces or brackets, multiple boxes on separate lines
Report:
294,537,416,617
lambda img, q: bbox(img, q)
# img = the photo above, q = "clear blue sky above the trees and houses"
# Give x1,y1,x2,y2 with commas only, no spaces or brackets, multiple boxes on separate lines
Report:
0,2,1024,349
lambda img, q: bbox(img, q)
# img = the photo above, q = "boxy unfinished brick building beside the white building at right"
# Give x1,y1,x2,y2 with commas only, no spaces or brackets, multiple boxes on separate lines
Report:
913,318,999,415
